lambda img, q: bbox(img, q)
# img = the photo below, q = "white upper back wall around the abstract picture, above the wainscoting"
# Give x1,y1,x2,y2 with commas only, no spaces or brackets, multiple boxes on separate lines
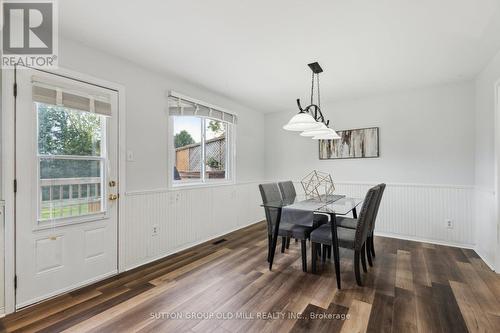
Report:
265,82,474,185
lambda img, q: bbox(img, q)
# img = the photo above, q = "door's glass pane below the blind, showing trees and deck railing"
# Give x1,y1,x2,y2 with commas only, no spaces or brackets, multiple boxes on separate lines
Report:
35,103,105,220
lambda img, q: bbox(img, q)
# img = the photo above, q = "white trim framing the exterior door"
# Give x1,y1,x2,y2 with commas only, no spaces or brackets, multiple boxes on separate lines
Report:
1,68,126,314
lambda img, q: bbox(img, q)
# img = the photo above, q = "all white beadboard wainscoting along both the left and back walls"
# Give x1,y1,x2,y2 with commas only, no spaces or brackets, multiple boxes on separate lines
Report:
120,182,477,271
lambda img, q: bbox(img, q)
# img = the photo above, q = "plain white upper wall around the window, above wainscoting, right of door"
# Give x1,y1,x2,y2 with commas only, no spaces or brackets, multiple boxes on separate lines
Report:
59,40,264,191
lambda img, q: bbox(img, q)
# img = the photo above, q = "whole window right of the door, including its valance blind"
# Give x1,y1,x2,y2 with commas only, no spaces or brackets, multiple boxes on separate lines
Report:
169,94,236,186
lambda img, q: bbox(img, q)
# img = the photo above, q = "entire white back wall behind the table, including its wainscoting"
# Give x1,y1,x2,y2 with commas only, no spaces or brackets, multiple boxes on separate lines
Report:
266,82,475,247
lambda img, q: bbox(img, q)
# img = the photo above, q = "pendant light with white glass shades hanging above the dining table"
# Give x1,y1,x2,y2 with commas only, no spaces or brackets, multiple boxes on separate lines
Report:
283,62,340,140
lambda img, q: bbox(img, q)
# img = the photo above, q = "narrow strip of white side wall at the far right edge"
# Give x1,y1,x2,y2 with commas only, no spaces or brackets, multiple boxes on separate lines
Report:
475,48,500,267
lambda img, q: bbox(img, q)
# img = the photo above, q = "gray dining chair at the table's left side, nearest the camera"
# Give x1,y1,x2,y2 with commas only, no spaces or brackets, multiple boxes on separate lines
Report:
259,183,312,272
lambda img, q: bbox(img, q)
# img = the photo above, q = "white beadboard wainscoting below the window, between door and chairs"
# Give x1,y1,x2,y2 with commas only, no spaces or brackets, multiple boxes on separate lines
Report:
119,182,264,271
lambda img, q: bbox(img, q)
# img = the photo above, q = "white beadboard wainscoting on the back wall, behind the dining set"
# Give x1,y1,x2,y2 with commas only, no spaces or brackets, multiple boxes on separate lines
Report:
296,182,475,248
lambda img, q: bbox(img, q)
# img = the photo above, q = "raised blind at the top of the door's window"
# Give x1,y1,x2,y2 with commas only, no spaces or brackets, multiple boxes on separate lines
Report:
32,77,112,116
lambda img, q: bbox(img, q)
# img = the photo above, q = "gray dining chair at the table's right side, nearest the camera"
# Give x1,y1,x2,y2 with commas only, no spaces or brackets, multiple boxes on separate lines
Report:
310,186,380,286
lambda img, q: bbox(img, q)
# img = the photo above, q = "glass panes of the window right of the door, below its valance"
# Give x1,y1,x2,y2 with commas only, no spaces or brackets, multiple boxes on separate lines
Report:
172,116,228,182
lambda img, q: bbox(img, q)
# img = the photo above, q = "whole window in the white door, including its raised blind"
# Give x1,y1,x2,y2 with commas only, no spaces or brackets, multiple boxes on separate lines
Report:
33,77,111,223
